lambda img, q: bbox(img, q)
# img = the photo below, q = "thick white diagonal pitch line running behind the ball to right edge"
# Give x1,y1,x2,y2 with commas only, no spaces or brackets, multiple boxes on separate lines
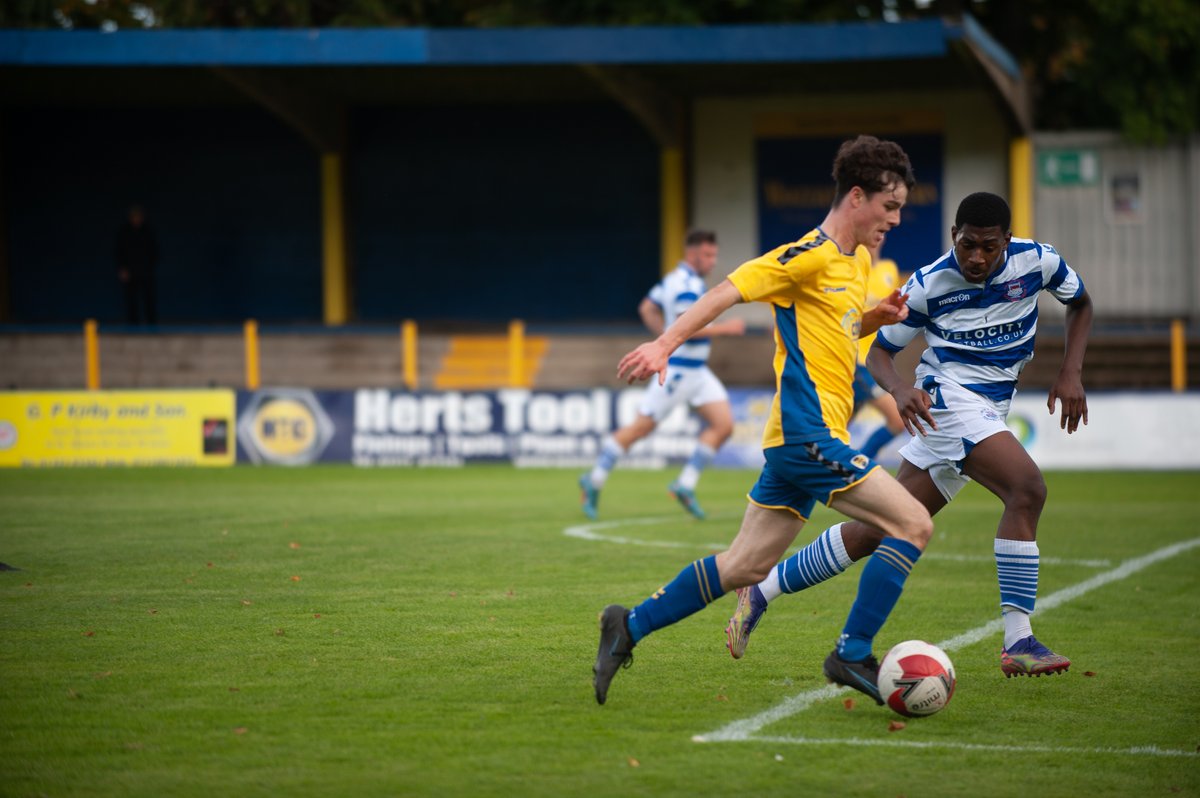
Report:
691,538,1200,743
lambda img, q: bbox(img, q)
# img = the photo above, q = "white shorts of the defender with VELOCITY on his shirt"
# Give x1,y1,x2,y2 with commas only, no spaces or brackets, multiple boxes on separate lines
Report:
900,378,1012,502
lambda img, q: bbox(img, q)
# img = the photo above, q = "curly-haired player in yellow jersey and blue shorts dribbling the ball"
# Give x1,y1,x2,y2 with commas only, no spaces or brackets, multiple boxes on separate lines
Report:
593,136,934,703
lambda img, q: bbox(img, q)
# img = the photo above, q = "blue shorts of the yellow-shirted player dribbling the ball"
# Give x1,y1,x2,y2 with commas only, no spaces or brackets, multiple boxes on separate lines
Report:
749,437,878,521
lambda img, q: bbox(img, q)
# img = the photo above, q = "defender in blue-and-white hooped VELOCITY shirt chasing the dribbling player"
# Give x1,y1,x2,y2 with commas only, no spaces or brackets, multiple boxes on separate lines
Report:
726,192,1092,676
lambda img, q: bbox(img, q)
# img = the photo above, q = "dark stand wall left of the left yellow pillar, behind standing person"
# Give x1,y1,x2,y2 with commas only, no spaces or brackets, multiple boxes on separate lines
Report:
4,109,322,323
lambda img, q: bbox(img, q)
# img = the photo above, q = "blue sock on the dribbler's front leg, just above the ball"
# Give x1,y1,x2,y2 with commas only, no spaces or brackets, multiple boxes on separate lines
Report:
838,538,920,662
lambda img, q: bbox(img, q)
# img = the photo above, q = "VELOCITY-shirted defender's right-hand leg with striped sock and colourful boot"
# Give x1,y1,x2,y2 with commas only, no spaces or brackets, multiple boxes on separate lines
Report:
962,432,1070,677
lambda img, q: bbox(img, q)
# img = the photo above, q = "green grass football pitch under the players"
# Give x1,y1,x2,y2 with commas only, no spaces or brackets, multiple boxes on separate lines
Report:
0,467,1200,797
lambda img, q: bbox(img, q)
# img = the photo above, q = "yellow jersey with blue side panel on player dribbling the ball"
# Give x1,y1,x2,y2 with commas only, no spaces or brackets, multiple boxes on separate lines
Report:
728,228,871,449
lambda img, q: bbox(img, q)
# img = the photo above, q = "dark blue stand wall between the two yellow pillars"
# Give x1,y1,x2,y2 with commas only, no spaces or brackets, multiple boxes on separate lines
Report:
348,106,659,322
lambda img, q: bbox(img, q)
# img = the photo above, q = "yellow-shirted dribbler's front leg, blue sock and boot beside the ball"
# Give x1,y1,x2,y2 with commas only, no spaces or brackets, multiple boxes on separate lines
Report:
824,468,934,703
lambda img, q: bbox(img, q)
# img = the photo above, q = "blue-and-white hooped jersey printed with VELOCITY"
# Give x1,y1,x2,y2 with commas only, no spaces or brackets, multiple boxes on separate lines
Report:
877,238,1084,402
